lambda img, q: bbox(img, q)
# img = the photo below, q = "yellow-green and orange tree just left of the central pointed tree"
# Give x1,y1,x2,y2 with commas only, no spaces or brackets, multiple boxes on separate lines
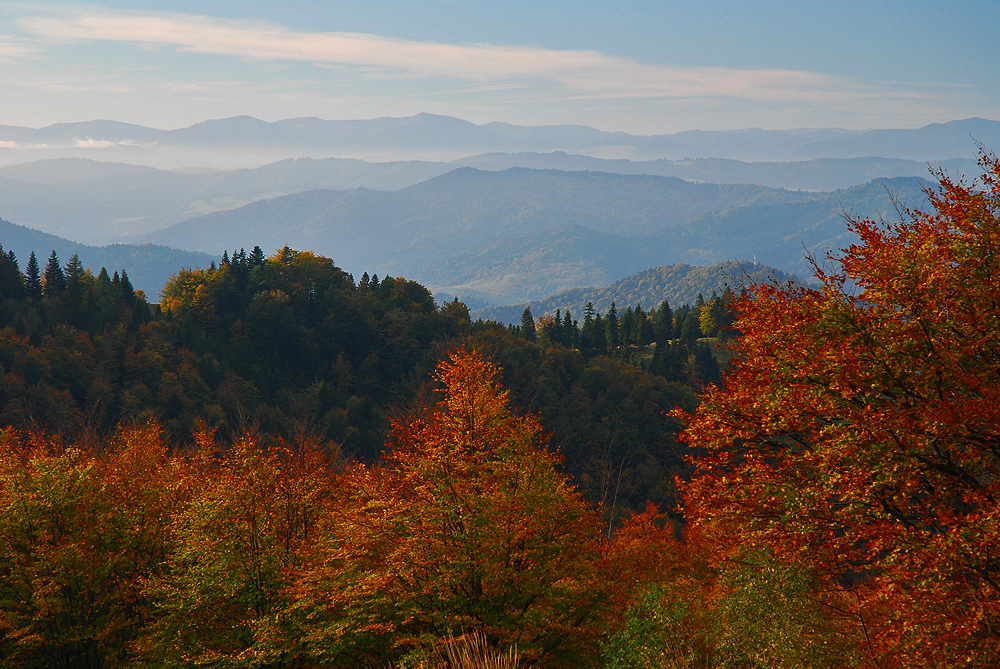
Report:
140,430,330,667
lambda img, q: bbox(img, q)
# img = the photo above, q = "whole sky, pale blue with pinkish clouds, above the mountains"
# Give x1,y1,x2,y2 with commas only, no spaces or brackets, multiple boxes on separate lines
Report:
0,0,1000,135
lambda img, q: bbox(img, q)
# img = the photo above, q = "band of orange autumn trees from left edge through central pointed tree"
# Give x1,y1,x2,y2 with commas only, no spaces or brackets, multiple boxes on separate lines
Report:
0,351,604,667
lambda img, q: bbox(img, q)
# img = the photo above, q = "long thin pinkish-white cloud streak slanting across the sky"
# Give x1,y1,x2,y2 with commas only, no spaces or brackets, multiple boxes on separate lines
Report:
13,8,914,104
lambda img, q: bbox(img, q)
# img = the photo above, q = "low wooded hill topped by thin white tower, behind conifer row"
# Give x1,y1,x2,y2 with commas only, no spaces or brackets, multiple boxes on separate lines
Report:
471,260,802,324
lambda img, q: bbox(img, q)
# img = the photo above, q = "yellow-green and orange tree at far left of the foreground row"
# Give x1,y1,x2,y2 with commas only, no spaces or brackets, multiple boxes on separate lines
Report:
0,426,175,667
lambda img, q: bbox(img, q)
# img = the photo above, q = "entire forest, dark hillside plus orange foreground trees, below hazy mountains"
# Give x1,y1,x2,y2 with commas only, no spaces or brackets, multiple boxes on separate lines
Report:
0,154,1000,669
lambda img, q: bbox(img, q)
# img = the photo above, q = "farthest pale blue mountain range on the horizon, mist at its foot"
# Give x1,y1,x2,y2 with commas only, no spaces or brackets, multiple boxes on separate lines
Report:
0,114,1000,168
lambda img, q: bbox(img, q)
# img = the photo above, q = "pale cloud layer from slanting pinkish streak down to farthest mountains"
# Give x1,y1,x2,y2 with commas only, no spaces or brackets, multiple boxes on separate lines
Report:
0,0,984,133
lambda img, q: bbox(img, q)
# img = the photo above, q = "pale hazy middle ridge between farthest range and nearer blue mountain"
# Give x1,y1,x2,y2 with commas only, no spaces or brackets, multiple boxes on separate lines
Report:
0,152,976,244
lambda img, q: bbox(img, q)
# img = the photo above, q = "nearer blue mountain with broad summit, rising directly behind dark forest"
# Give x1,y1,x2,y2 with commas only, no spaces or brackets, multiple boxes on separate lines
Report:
136,168,927,304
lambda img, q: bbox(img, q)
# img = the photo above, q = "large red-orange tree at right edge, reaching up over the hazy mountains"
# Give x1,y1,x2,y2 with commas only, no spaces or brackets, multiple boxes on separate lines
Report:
686,156,1000,667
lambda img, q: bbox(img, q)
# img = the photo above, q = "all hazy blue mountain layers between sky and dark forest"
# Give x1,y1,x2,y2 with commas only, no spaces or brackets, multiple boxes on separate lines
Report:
0,114,984,307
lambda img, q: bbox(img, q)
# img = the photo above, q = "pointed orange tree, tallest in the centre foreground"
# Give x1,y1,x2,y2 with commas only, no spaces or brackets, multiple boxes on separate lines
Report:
286,351,598,666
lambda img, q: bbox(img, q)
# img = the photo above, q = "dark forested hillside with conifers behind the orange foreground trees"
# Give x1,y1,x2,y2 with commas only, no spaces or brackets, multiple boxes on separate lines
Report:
0,247,704,514
